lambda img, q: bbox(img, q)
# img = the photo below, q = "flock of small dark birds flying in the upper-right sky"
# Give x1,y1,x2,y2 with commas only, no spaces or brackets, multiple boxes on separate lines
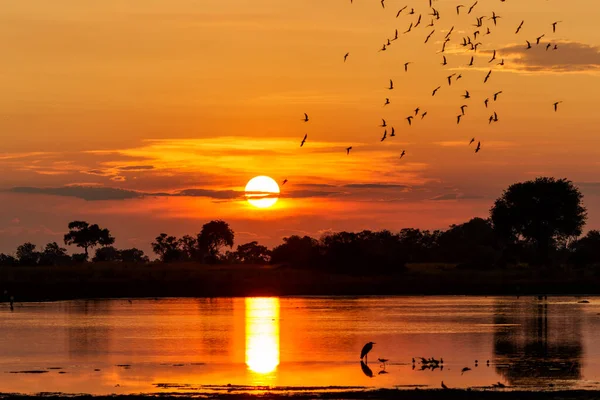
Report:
300,0,562,162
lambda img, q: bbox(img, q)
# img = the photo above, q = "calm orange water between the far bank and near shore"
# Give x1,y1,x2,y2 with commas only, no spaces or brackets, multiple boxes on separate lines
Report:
0,297,600,394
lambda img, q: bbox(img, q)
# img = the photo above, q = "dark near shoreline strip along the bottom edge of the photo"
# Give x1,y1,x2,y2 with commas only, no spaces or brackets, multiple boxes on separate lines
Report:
0,389,600,400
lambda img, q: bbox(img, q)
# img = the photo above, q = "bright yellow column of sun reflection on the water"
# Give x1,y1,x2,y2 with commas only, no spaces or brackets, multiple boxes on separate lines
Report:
246,297,279,374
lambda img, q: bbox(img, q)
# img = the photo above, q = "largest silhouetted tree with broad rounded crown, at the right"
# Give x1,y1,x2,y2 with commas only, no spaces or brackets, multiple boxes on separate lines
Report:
491,178,587,262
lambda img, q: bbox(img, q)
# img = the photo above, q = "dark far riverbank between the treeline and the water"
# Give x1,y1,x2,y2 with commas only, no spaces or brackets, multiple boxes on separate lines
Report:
0,263,600,301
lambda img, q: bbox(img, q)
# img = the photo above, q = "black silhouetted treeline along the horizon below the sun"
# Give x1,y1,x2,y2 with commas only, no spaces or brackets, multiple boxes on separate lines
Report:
0,178,600,274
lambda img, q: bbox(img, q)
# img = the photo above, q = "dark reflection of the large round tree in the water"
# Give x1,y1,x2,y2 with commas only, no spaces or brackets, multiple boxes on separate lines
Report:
494,299,583,385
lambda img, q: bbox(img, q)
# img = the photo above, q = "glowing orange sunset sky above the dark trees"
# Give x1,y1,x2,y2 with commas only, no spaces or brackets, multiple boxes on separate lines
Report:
0,0,600,252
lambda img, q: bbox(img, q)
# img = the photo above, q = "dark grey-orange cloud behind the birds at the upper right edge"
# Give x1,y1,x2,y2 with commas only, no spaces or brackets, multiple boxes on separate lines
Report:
498,42,600,73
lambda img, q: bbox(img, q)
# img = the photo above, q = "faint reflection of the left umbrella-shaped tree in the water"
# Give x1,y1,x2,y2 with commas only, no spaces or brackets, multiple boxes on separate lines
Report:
66,300,111,359
